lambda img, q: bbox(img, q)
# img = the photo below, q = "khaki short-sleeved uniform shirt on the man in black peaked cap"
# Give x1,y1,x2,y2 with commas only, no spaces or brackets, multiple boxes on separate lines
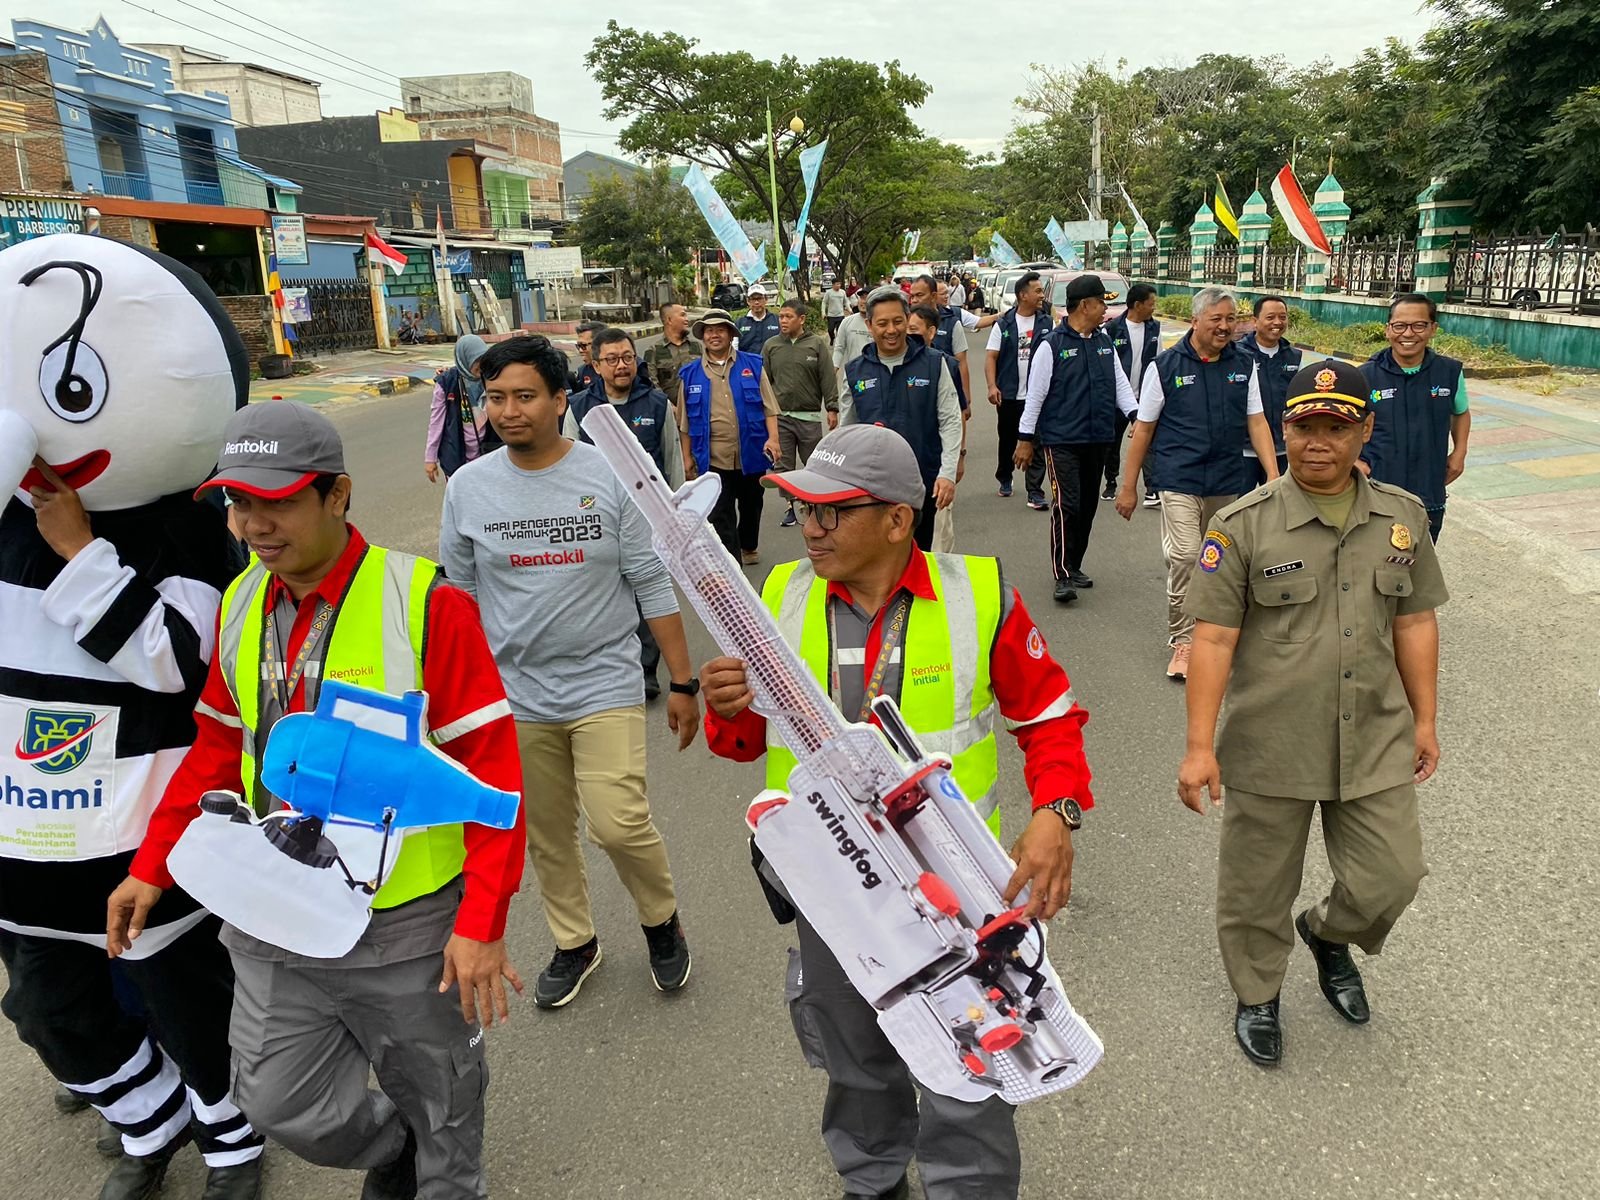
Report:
1186,474,1448,800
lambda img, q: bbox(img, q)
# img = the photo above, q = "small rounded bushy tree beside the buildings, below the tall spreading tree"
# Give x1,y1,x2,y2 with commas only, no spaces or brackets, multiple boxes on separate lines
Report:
578,163,706,280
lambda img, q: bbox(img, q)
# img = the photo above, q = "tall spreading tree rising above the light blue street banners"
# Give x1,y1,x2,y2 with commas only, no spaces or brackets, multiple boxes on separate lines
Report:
584,21,928,289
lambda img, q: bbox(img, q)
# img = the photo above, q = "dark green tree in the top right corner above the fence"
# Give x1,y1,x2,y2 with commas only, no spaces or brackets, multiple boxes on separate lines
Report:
1419,0,1600,230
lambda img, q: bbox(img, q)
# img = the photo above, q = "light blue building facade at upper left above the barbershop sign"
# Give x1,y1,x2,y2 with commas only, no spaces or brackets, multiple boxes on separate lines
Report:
0,18,299,210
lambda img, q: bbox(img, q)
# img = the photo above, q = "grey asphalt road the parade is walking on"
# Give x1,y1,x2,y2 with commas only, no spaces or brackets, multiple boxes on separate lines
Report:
0,355,1600,1200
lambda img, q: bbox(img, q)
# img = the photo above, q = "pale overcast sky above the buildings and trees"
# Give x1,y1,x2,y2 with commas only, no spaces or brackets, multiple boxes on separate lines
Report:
28,0,1432,158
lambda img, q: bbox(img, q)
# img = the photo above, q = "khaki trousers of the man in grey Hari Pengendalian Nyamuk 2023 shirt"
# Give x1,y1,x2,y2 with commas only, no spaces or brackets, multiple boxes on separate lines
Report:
517,704,678,950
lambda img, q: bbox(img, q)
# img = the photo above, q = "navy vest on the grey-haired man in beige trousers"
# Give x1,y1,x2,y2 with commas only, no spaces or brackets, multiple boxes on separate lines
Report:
1146,333,1256,496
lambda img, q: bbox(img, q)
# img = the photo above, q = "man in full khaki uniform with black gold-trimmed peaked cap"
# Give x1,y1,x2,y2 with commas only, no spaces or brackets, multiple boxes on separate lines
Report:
1178,360,1446,1064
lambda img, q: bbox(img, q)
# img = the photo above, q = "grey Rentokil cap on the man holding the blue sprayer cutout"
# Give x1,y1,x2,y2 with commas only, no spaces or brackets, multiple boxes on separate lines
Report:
195,400,344,499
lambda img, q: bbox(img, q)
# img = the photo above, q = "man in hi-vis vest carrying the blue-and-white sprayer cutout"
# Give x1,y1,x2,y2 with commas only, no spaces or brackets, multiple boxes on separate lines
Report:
106,403,525,1200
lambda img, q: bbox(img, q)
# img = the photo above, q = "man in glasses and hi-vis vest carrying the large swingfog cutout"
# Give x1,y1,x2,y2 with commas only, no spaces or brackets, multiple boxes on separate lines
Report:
701,426,1093,1200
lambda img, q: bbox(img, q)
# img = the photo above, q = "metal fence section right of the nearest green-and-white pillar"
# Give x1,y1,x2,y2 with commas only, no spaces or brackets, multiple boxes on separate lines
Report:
1448,226,1600,315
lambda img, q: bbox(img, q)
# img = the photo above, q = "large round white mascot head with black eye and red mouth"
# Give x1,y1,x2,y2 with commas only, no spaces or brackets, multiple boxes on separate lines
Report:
0,234,250,512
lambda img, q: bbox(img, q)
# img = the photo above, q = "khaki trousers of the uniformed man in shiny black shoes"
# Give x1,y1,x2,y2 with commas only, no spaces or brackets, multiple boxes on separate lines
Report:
1216,784,1427,1005
